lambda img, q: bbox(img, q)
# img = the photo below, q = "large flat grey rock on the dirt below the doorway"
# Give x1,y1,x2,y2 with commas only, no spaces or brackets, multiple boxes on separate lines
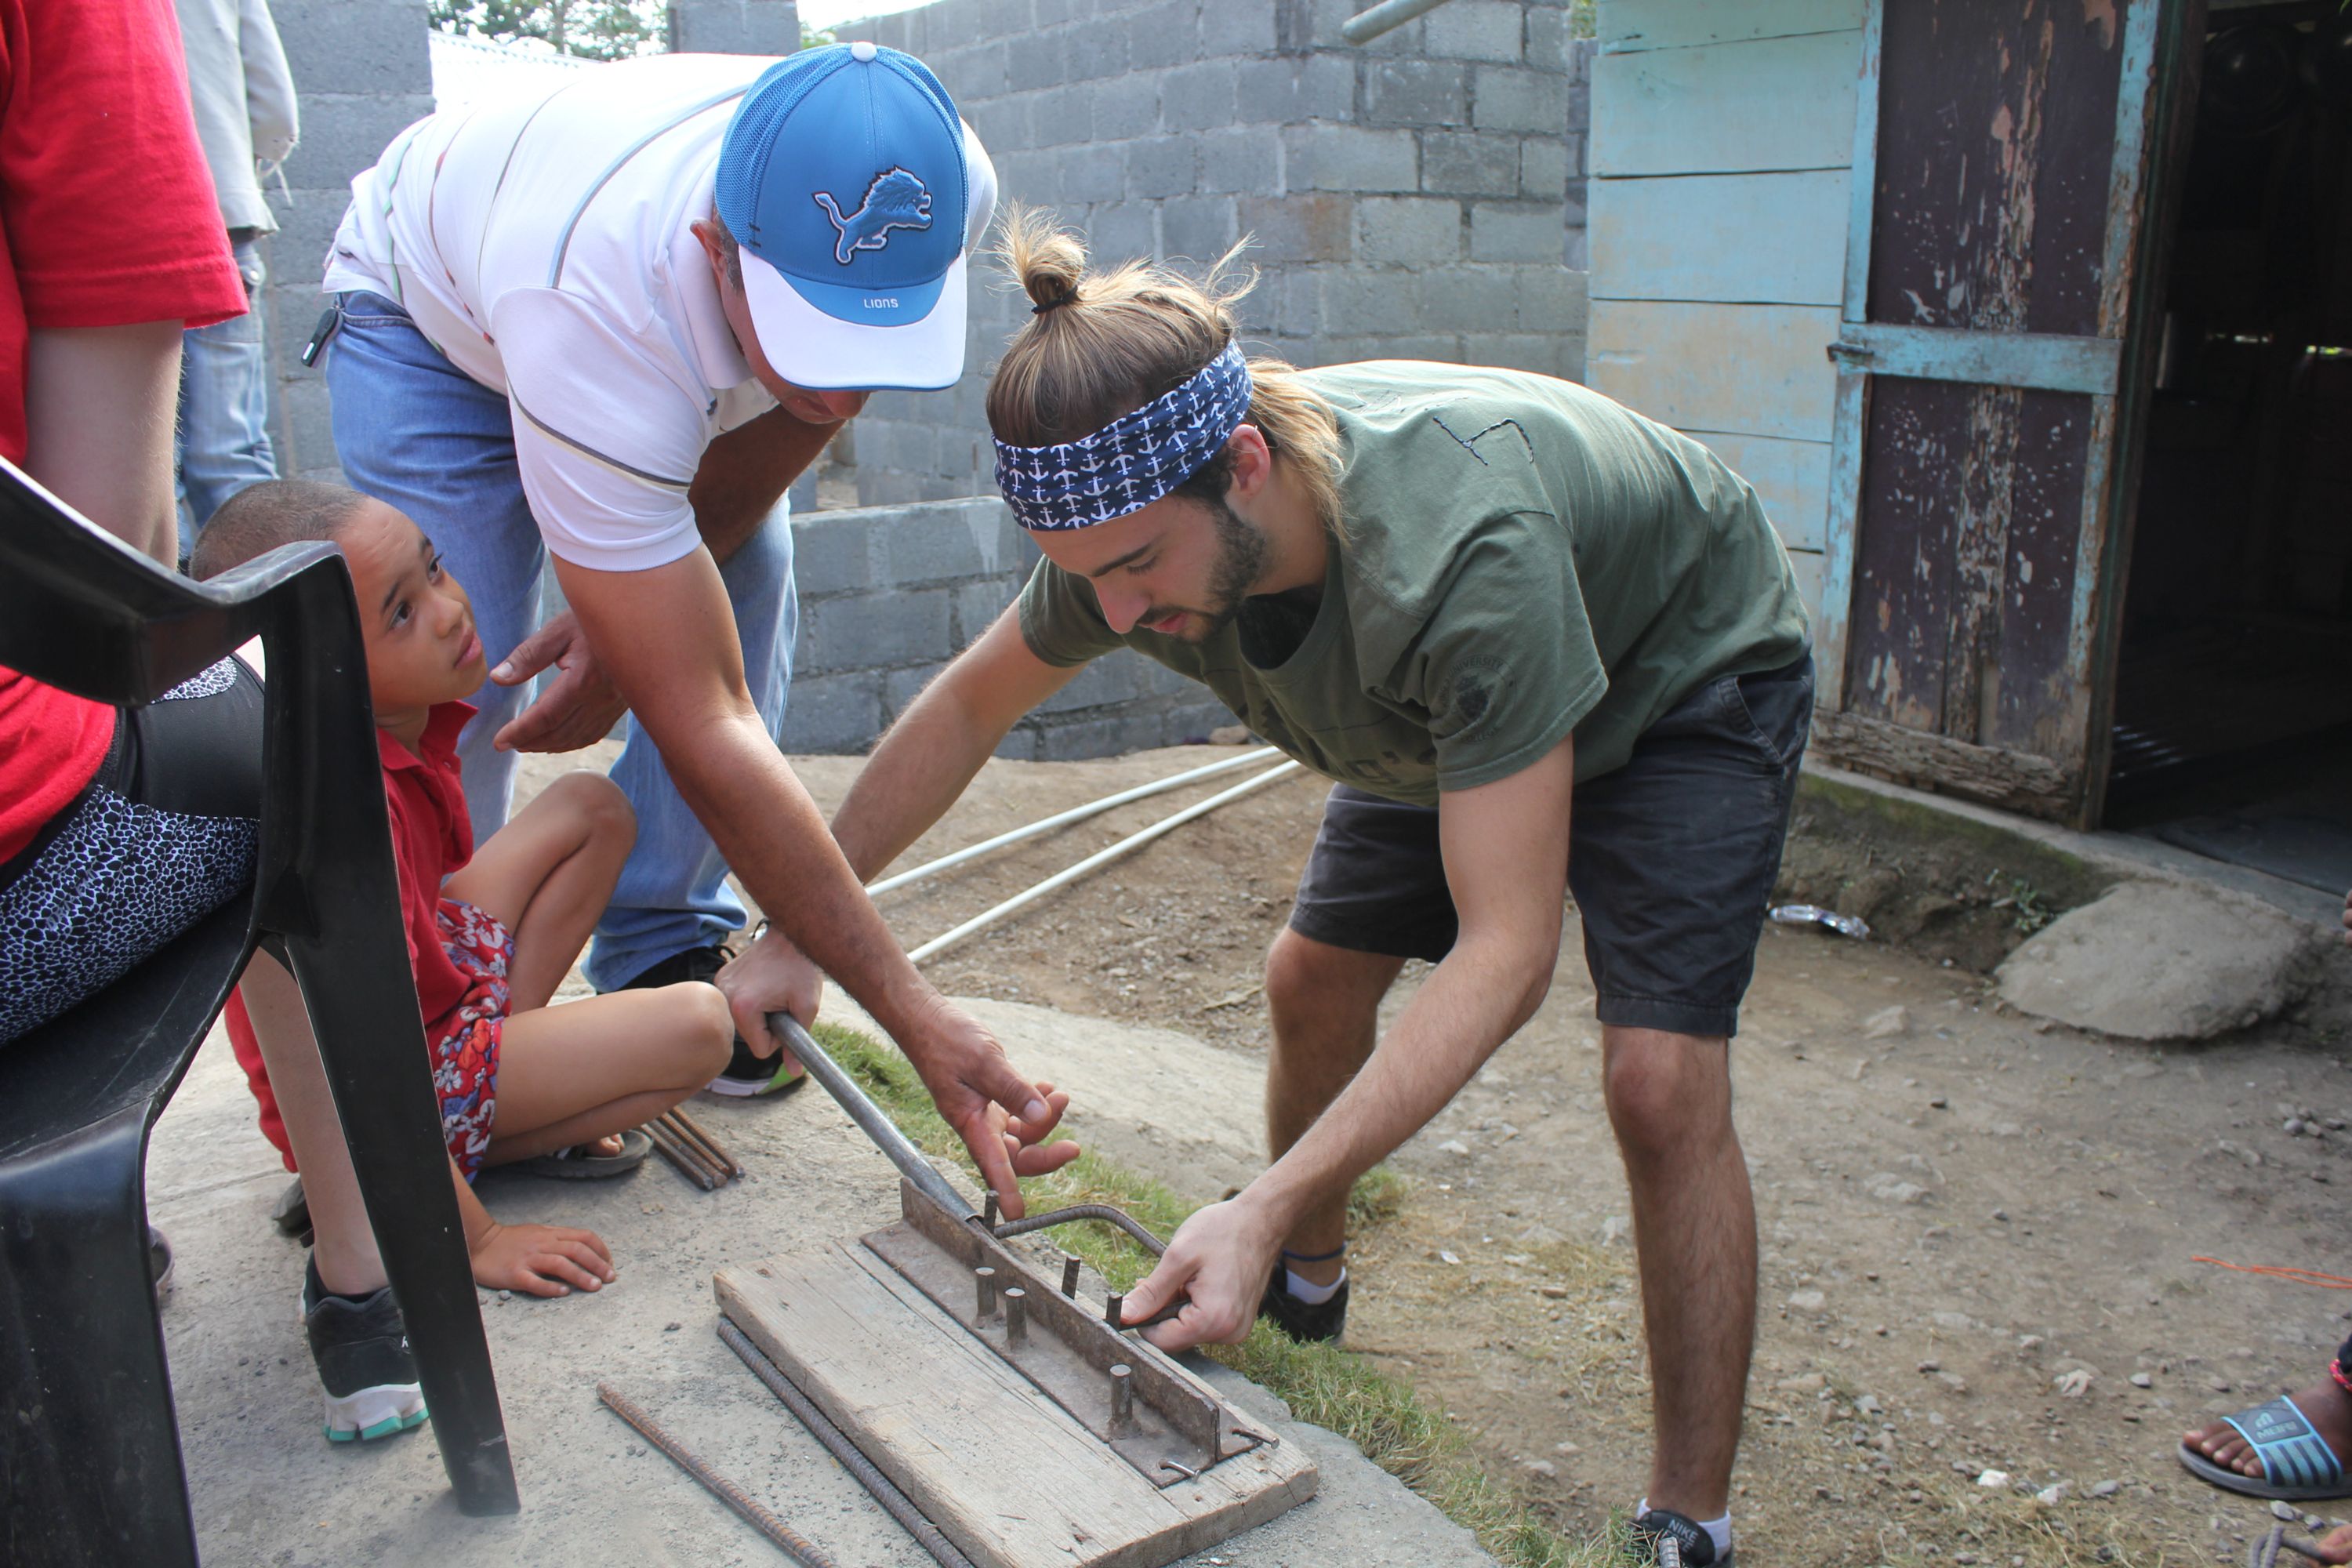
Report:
1997,881,2312,1039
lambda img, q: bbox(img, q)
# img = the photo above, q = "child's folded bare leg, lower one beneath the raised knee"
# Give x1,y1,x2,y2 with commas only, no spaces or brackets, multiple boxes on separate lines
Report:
485,982,734,1163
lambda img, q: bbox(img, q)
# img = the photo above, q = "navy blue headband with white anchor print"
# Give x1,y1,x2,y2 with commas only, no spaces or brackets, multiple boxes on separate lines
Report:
997,343,1249,532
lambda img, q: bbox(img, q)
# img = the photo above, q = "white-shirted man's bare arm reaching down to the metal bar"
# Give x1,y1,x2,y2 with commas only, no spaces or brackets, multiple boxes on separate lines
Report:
555,550,1077,1213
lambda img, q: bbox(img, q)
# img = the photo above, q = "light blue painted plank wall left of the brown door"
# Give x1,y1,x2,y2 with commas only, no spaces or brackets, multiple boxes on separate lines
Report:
1585,0,1867,609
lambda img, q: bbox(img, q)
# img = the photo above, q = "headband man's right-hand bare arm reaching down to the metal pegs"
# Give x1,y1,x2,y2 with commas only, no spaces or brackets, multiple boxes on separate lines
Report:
1127,741,1576,1349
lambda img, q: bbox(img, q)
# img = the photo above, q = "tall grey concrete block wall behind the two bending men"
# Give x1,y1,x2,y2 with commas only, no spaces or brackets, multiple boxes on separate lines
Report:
837,0,1592,506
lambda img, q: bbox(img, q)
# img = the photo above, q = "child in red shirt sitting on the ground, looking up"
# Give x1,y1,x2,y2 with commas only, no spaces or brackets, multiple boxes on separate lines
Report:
193,480,734,1441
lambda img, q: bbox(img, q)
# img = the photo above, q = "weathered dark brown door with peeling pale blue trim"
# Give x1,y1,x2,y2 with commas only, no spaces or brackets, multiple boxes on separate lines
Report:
1820,0,2201,820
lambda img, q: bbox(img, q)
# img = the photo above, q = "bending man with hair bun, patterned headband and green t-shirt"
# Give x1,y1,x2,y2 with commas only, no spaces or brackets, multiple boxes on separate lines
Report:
748,219,1811,1563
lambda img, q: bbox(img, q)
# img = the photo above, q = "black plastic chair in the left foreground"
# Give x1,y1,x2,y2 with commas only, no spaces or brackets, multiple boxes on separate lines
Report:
0,461,522,1568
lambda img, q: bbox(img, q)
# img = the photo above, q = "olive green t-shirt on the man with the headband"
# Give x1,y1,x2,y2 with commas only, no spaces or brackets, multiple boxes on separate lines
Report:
1021,360,1806,806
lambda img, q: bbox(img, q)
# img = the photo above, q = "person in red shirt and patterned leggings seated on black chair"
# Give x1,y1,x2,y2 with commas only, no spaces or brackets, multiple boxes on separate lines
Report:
0,0,482,1436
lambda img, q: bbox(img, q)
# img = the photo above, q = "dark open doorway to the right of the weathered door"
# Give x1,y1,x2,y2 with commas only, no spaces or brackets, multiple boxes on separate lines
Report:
2105,0,2352,893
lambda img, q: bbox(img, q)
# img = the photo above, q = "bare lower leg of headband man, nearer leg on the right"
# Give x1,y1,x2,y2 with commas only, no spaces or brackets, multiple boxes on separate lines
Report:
1602,1025,1757,1519
